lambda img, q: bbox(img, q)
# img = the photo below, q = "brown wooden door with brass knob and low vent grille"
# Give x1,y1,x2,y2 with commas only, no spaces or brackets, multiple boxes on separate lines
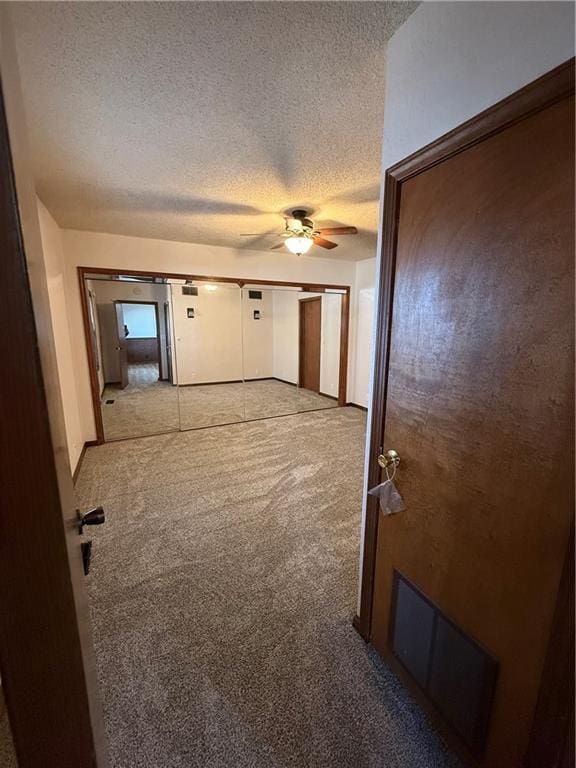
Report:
372,97,574,768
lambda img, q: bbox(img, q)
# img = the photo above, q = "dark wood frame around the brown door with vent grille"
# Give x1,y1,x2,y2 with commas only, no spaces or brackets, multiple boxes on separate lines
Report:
353,58,574,766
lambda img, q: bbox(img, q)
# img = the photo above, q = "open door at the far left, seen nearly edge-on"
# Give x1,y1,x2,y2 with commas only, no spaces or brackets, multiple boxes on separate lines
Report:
0,71,107,768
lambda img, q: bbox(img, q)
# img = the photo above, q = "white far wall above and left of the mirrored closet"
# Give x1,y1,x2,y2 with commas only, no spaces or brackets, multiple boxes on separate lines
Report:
62,230,355,440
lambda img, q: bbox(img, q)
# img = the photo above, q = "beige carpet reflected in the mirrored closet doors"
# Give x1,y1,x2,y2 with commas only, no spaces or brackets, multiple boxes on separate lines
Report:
102,370,338,440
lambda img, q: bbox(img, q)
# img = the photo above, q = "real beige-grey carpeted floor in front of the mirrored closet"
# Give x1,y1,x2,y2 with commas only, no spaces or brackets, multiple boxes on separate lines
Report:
77,408,457,768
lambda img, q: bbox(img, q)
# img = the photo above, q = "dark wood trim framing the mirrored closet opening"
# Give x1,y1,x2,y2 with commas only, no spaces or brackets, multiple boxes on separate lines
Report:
77,267,351,445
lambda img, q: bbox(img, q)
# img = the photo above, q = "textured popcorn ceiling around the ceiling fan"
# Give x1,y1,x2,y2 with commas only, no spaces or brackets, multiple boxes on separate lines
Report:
14,2,416,259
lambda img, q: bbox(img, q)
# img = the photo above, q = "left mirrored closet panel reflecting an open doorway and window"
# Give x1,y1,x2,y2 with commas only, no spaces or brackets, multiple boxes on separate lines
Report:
85,276,179,440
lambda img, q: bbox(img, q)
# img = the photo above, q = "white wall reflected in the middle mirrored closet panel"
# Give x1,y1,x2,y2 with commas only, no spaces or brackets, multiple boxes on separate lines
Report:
171,285,242,386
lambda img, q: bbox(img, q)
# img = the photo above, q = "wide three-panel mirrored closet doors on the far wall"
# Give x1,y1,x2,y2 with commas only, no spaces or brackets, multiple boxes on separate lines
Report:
83,270,346,441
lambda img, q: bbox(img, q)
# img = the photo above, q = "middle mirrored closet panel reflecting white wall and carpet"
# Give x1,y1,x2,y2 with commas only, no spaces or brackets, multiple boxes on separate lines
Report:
171,281,245,429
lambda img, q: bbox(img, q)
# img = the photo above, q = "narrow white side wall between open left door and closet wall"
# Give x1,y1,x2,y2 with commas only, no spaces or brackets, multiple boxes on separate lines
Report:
38,200,84,472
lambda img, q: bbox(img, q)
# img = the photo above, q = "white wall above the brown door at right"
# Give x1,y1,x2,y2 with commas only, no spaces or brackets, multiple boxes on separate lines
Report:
360,2,574,612
